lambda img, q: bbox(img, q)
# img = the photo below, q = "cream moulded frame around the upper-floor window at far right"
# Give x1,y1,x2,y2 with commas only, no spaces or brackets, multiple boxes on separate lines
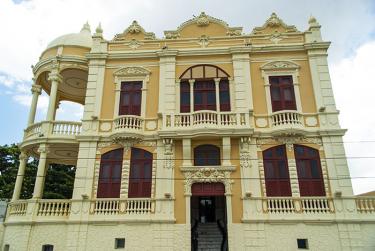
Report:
260,61,302,114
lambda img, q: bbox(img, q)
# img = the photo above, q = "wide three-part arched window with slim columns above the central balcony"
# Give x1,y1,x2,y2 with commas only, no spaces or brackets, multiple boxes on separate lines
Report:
180,65,230,113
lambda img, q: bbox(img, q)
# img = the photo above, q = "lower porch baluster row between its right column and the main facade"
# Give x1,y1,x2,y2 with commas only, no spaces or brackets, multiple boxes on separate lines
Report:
37,200,71,216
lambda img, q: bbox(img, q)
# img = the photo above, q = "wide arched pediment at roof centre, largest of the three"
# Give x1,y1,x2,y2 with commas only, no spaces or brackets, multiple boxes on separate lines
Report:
164,12,242,39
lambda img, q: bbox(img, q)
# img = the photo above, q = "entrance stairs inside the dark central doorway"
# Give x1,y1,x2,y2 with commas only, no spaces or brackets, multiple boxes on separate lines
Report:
197,222,223,251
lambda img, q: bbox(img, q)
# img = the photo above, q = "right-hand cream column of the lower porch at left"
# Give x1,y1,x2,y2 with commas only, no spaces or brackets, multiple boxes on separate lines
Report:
33,144,48,199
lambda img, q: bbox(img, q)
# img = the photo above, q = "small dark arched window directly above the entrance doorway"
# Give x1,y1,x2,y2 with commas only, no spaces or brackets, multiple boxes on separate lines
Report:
194,145,220,166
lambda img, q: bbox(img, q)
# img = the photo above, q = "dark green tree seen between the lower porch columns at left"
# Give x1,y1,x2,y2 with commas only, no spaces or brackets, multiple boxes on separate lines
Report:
0,144,75,199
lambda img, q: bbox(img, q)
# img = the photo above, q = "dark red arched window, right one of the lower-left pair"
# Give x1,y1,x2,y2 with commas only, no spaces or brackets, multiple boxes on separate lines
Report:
128,148,152,198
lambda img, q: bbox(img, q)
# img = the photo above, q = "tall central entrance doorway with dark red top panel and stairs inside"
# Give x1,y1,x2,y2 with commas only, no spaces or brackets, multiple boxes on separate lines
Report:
190,182,227,250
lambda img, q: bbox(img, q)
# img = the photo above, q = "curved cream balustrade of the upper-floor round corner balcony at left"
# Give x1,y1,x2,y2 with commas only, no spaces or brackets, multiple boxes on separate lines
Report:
24,121,82,140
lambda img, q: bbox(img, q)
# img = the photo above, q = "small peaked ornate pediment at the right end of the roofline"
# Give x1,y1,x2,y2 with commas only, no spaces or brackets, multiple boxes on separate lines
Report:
252,13,298,35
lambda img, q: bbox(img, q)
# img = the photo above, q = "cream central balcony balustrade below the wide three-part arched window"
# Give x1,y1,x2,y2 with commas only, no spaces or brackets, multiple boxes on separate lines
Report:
160,110,252,136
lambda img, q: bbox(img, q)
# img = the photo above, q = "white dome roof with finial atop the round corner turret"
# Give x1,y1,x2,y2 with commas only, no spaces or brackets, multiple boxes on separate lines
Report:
46,23,92,49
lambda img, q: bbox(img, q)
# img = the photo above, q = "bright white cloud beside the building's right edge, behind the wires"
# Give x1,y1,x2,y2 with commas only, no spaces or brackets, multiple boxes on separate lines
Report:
331,41,375,193
